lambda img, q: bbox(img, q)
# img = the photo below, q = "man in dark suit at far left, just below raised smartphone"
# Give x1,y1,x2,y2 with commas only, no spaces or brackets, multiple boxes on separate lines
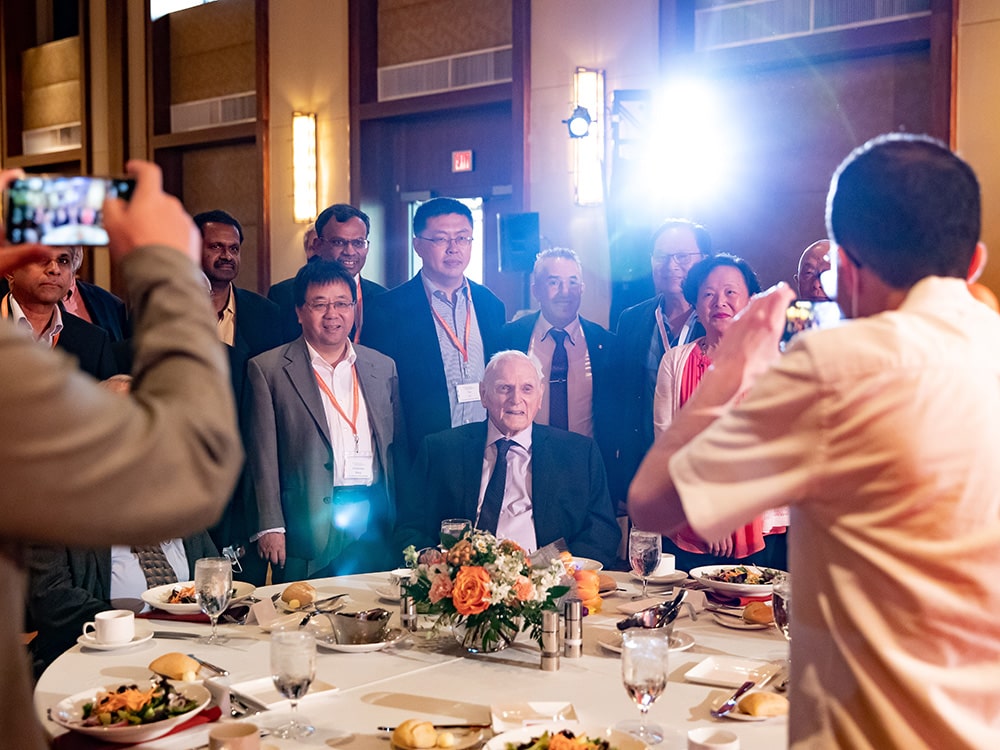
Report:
0,247,118,380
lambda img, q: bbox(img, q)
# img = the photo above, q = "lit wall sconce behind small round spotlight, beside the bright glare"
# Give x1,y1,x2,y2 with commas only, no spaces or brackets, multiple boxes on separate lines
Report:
566,68,606,206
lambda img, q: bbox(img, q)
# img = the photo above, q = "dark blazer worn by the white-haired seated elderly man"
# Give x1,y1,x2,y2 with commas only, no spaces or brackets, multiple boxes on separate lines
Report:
396,421,621,566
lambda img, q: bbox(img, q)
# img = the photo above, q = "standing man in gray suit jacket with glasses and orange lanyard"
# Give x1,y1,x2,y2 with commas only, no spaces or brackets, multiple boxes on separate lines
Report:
244,260,406,582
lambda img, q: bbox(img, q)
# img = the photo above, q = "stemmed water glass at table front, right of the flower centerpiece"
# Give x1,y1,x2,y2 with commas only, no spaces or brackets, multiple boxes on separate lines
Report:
616,628,670,745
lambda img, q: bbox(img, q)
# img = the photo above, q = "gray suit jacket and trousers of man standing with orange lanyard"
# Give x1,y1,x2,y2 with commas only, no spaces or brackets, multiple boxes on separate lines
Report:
243,337,406,582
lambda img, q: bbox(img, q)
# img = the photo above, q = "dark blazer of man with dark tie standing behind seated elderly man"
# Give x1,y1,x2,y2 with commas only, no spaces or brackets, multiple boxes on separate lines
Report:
500,312,626,505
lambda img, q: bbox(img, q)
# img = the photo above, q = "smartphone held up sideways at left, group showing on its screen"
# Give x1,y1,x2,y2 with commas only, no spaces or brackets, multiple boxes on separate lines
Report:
4,175,135,246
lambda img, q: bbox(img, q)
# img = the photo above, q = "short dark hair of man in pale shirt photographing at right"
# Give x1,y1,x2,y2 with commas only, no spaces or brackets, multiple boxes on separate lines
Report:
826,133,981,289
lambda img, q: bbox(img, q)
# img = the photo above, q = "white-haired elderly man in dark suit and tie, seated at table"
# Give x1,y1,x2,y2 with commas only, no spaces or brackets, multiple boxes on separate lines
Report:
396,351,621,565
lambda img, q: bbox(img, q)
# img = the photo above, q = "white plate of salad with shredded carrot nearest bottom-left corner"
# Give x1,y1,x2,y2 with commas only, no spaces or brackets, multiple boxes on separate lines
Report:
49,679,212,744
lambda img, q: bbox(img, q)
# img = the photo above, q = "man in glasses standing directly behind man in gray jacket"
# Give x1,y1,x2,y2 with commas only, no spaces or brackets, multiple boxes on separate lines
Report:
267,209,388,344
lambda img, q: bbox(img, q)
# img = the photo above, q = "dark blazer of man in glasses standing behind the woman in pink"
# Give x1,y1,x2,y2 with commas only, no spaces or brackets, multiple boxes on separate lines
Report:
615,296,705,492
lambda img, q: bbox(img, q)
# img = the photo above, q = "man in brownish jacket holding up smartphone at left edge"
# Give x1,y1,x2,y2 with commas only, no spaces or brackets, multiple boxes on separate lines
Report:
0,161,242,750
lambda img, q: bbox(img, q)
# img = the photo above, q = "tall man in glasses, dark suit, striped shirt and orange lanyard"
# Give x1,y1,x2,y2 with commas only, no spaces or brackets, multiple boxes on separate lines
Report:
361,198,507,450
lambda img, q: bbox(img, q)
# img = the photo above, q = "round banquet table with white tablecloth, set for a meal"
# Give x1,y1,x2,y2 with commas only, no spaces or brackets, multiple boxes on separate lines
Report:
34,573,788,750
